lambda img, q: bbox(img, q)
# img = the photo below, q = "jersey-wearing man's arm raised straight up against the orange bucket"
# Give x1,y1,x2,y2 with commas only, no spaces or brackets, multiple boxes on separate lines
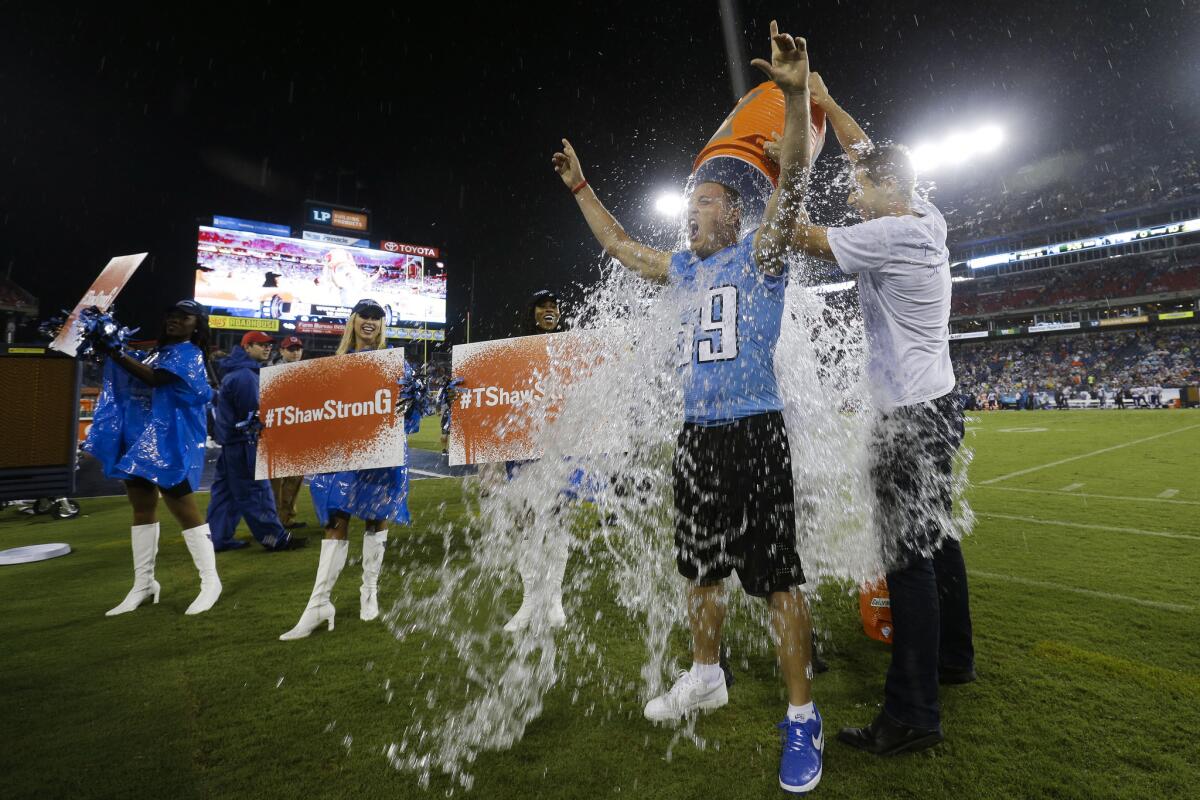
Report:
750,20,812,275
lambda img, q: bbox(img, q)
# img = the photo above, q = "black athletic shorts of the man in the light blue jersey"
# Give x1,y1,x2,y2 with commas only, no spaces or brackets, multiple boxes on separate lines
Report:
673,411,804,597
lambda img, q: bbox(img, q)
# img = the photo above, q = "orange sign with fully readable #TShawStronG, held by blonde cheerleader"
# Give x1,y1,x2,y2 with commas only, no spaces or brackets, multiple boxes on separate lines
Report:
254,348,408,480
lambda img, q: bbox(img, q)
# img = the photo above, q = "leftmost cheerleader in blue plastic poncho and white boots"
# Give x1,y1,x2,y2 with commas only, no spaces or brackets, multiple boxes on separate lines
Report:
83,300,221,616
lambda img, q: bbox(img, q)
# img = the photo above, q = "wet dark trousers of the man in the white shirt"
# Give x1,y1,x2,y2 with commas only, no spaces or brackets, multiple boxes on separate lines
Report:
871,395,974,730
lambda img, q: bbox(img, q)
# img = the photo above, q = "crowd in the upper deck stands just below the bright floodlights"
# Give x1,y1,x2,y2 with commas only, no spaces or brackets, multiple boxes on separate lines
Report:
937,137,1200,248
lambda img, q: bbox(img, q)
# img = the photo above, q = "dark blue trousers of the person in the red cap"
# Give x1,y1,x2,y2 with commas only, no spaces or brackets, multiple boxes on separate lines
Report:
208,441,289,551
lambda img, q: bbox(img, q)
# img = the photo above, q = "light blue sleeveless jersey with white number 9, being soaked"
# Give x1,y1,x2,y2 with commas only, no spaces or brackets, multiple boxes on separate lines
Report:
670,231,787,425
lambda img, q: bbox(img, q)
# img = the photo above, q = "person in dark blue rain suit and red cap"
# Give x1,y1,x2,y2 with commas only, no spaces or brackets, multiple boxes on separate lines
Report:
208,331,307,553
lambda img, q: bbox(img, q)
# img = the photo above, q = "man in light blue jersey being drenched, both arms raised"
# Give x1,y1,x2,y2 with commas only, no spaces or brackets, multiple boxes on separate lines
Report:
553,22,824,793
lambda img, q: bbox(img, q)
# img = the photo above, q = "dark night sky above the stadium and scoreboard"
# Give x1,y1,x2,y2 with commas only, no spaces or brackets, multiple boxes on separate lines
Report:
0,0,1200,341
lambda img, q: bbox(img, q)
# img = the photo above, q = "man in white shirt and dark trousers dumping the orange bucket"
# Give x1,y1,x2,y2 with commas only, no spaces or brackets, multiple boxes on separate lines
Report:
794,73,976,756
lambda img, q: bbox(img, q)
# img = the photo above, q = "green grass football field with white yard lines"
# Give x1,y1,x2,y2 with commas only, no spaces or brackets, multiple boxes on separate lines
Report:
0,410,1200,800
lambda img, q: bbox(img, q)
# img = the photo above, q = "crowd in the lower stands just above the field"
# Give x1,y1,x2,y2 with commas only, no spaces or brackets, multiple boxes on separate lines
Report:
950,325,1200,405
